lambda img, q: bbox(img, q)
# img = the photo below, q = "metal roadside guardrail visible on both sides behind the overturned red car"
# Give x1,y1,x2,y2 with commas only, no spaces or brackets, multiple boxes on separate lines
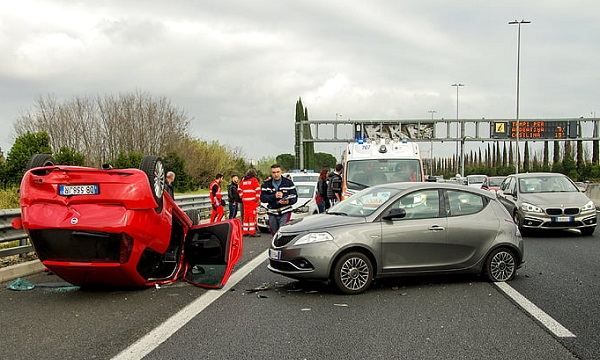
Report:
0,193,227,258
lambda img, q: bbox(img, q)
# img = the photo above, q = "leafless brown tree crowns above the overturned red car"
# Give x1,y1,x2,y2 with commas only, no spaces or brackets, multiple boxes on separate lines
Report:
14,92,189,165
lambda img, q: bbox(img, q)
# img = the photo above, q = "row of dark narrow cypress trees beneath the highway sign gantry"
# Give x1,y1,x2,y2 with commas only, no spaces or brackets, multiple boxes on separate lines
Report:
428,140,600,181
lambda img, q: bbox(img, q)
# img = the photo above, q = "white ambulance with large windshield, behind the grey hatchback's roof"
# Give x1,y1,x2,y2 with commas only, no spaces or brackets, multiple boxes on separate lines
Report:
342,138,425,198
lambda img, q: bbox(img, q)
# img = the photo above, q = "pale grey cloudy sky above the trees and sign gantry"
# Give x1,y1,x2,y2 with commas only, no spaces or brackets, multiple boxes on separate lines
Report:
0,0,600,159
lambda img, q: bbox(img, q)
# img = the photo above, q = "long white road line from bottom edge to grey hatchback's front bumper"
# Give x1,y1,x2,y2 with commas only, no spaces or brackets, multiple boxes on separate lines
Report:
113,250,267,360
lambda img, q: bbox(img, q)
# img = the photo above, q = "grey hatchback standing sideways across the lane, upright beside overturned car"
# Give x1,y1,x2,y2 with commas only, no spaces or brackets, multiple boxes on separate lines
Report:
268,183,523,294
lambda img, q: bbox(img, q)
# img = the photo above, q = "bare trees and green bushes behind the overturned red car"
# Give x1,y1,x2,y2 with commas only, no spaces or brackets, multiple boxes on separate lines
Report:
0,92,249,192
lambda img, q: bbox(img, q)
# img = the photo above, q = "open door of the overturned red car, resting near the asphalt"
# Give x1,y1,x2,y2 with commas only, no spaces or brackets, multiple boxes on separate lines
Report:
183,219,243,289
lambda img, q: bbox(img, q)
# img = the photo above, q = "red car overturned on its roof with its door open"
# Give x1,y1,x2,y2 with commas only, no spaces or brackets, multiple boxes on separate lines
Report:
13,154,242,288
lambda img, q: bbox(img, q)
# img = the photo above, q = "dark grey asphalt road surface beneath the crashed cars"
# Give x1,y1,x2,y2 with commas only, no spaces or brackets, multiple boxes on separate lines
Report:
0,232,600,359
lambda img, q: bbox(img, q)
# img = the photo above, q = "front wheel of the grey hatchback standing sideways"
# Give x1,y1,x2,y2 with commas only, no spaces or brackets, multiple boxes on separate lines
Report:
333,252,373,295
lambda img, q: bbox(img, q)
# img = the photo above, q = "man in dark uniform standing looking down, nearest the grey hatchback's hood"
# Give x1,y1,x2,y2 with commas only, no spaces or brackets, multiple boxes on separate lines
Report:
260,164,298,234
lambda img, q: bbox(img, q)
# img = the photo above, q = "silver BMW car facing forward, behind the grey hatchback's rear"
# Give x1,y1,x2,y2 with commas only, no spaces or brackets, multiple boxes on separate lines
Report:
497,173,596,235
